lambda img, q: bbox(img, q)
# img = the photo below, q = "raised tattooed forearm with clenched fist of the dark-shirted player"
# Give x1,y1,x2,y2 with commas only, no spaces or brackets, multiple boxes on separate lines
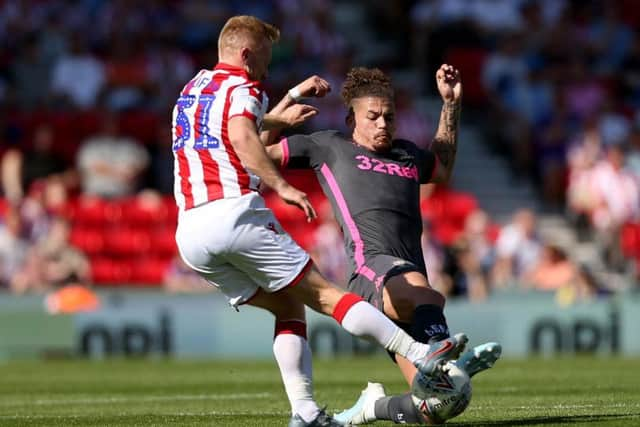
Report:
431,64,462,182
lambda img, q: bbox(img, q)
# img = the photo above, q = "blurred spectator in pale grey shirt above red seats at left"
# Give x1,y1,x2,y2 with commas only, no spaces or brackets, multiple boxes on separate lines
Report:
77,114,149,198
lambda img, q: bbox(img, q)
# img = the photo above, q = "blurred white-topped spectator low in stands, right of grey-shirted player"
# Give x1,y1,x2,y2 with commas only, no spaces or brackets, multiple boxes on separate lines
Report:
492,209,542,287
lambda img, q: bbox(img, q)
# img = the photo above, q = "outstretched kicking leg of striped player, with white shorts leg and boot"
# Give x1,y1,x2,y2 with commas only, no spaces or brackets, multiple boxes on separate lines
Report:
225,196,467,392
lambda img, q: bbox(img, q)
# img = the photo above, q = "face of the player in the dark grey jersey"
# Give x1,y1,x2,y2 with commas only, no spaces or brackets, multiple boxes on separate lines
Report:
352,96,395,151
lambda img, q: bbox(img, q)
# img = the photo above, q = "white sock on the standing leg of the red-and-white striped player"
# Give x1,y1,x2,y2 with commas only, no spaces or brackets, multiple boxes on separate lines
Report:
273,324,320,422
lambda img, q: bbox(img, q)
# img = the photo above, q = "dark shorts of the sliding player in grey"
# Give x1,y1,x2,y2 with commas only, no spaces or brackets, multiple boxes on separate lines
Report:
347,255,424,311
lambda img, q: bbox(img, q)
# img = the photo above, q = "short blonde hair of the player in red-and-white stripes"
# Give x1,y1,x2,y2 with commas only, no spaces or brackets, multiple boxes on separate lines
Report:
218,15,280,53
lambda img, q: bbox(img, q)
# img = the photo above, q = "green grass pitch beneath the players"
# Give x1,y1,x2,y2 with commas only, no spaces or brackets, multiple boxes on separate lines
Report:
0,357,640,427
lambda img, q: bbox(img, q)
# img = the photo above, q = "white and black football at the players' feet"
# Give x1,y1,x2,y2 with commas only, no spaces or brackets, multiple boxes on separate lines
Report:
411,362,471,424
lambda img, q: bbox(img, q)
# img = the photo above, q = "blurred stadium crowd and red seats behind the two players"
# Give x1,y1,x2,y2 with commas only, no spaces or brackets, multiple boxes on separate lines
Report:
0,0,640,303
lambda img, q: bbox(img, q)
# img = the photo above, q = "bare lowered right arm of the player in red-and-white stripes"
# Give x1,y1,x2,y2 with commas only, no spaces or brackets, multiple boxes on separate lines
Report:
229,116,316,221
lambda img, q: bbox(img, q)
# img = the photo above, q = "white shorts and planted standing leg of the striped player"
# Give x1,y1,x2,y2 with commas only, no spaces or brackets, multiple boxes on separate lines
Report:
176,197,337,427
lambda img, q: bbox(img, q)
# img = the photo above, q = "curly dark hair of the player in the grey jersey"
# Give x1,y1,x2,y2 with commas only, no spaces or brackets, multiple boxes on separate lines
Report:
340,67,394,108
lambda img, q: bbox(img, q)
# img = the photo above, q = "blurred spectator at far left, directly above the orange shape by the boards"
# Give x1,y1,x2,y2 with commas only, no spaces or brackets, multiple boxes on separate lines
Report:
11,217,90,293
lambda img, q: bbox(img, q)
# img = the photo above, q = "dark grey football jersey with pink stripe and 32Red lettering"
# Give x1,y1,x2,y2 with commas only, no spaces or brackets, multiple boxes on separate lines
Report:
282,131,436,278
